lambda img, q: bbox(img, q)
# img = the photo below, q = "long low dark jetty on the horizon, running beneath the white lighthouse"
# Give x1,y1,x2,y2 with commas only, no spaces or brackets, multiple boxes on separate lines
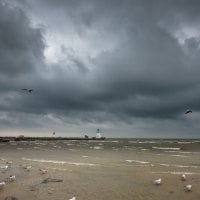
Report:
0,135,105,142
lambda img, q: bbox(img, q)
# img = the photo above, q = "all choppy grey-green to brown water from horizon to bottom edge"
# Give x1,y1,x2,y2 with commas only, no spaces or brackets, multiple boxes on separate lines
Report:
0,138,200,200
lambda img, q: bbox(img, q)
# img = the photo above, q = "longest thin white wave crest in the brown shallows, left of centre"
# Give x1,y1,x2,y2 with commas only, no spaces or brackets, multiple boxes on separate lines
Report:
22,158,99,166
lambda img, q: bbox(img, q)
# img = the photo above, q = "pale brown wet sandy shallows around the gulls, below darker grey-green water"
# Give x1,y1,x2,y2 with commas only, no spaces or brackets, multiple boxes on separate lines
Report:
0,139,200,200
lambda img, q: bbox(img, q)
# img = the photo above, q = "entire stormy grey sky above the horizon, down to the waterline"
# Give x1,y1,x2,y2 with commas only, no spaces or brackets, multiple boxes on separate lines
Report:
0,0,200,138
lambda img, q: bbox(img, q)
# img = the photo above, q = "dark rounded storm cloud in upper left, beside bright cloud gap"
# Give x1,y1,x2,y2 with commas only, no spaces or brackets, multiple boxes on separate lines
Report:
0,4,44,76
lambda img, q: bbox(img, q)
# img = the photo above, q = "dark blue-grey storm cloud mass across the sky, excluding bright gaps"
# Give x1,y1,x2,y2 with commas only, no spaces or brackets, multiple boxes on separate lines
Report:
0,0,200,136
